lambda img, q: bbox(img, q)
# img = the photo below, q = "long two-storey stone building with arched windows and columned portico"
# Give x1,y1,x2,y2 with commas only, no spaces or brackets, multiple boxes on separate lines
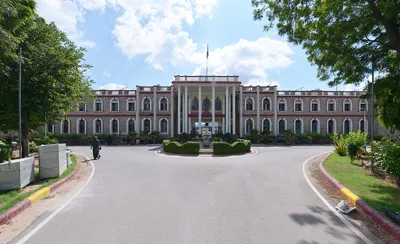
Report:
45,76,398,137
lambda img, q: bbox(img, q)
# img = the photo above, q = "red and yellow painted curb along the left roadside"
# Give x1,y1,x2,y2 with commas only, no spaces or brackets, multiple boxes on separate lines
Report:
0,153,79,225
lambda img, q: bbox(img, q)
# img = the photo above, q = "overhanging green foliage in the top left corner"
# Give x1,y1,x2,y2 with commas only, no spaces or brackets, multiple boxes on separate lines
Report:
0,0,35,74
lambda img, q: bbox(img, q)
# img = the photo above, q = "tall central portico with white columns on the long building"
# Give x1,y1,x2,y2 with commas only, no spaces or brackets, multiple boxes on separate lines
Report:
173,76,240,134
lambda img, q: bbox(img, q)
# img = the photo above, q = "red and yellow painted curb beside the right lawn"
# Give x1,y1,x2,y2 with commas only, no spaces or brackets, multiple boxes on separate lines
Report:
319,155,400,241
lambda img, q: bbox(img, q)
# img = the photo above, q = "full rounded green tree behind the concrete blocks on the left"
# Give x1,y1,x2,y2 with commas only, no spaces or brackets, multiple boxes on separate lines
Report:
0,17,92,156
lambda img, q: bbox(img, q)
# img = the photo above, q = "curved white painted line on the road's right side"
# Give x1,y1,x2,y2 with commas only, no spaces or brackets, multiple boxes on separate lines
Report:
303,152,374,244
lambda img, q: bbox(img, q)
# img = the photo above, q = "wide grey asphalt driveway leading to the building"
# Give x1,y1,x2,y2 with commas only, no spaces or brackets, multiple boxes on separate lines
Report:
10,146,376,244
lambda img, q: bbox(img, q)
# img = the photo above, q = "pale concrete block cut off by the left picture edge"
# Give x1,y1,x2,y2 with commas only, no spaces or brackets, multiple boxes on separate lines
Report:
0,157,35,191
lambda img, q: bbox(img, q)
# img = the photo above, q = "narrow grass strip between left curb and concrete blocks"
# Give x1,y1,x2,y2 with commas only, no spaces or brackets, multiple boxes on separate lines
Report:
0,154,78,214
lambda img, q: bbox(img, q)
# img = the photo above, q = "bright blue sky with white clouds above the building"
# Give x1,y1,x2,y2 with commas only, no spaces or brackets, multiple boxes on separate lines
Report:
36,0,356,90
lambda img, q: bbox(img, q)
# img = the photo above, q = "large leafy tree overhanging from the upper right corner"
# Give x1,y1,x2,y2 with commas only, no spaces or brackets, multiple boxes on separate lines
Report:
252,0,400,129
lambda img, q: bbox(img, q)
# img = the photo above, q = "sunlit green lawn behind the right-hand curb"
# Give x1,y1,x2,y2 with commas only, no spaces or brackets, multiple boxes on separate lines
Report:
324,153,400,213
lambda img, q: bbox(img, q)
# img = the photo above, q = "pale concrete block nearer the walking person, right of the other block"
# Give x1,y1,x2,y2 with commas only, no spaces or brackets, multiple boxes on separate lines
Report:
38,144,67,179
